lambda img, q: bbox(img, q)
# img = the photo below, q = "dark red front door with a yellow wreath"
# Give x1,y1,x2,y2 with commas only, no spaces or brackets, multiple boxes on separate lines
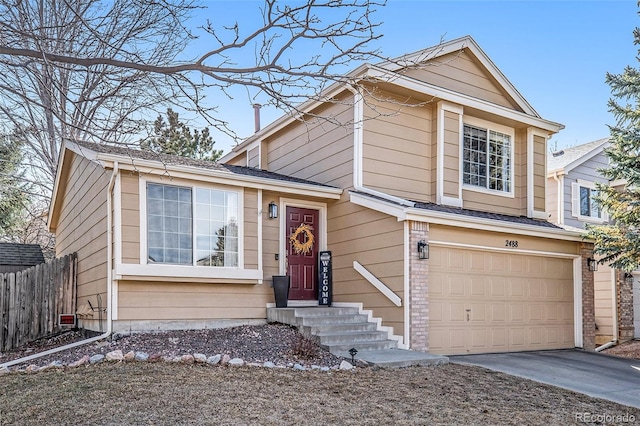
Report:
286,207,319,300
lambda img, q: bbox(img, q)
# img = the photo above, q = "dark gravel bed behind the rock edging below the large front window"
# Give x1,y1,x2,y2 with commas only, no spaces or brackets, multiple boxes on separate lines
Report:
0,324,343,369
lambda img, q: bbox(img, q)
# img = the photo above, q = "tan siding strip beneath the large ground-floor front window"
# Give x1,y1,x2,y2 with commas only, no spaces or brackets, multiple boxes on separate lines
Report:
118,281,273,321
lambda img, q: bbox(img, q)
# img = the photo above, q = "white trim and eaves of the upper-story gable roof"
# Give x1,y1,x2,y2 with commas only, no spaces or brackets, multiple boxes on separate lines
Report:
220,36,564,162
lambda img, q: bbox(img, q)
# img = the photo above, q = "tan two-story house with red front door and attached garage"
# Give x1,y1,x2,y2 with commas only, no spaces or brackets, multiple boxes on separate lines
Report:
50,37,594,354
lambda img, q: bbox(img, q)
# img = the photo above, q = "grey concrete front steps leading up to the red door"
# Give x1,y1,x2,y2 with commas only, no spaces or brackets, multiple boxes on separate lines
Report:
267,306,398,356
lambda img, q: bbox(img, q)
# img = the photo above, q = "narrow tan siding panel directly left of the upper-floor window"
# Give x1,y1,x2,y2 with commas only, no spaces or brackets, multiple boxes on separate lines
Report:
442,111,462,198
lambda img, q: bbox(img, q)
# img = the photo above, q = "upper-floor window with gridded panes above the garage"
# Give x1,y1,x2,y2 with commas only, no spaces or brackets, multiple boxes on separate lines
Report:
462,124,512,192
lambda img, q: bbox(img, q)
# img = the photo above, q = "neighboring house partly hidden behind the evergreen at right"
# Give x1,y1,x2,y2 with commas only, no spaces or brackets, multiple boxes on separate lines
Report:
547,138,640,345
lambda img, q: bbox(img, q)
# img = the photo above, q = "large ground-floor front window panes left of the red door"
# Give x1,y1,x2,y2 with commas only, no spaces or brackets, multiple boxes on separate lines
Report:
146,183,239,267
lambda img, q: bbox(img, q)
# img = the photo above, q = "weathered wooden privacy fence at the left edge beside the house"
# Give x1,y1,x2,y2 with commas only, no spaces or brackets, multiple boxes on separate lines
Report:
0,253,78,351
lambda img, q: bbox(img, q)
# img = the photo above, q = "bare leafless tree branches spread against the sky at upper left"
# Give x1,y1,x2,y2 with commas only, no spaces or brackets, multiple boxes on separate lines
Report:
0,0,400,203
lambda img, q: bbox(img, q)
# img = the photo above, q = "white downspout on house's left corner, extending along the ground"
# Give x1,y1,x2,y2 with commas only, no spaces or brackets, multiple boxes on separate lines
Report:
0,161,118,370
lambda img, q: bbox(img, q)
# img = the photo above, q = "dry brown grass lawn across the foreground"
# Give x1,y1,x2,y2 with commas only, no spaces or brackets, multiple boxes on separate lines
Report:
0,362,640,425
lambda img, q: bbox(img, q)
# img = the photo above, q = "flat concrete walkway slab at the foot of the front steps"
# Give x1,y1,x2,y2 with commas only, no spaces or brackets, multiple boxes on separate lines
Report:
336,349,449,368
